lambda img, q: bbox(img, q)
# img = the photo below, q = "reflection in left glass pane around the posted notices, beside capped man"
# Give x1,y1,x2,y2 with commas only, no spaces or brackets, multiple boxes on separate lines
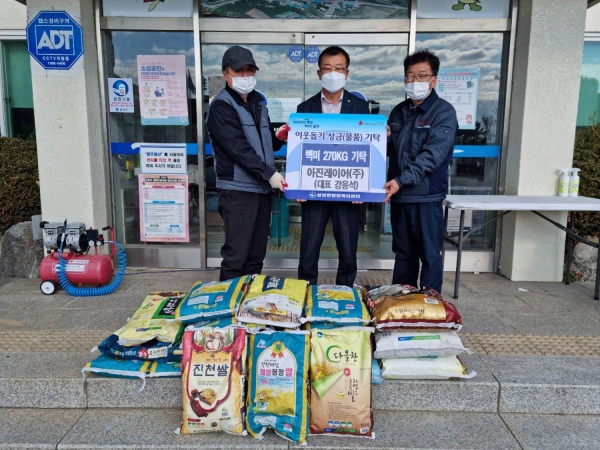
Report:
105,31,200,245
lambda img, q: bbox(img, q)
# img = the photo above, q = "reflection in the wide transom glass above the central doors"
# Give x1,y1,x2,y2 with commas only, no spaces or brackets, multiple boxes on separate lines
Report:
200,0,409,19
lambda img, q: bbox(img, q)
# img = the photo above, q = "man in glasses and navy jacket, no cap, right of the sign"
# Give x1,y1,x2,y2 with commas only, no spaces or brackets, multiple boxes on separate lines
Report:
384,50,458,292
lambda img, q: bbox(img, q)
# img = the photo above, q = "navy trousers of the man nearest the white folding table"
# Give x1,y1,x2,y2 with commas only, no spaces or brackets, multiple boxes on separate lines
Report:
390,200,444,293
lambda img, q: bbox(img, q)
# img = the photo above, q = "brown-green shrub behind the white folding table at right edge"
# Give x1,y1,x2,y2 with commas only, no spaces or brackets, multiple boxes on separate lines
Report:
573,117,600,236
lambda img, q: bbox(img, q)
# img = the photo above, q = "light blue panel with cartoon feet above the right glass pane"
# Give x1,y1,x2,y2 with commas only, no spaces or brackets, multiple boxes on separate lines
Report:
417,0,510,19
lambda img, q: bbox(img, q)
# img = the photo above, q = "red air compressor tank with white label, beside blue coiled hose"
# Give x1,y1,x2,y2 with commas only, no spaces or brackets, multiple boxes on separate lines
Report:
40,252,115,286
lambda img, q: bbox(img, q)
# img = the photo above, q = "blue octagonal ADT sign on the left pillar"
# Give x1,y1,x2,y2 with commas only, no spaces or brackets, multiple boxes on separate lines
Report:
27,11,83,70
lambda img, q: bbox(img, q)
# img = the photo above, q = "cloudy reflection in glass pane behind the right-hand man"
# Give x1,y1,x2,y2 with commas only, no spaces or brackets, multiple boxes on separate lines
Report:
416,33,505,250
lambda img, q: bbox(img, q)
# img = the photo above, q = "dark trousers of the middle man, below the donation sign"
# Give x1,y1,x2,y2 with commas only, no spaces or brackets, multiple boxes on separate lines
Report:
298,200,360,287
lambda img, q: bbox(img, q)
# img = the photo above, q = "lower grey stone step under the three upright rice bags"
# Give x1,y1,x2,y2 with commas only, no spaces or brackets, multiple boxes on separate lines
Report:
0,408,600,450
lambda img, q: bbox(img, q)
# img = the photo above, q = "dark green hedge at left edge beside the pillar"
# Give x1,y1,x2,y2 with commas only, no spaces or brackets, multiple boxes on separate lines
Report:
0,137,42,234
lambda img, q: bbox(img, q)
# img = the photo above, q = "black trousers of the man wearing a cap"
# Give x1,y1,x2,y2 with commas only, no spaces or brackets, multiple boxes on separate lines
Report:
218,189,271,281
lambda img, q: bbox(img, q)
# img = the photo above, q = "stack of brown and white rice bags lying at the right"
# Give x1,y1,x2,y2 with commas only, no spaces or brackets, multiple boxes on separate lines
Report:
364,285,477,379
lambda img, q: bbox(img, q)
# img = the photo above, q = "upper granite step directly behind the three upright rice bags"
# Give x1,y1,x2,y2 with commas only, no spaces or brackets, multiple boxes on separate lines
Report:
0,352,600,414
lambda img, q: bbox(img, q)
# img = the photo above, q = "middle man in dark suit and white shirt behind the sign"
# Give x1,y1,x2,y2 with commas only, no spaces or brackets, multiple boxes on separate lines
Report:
297,46,369,287
